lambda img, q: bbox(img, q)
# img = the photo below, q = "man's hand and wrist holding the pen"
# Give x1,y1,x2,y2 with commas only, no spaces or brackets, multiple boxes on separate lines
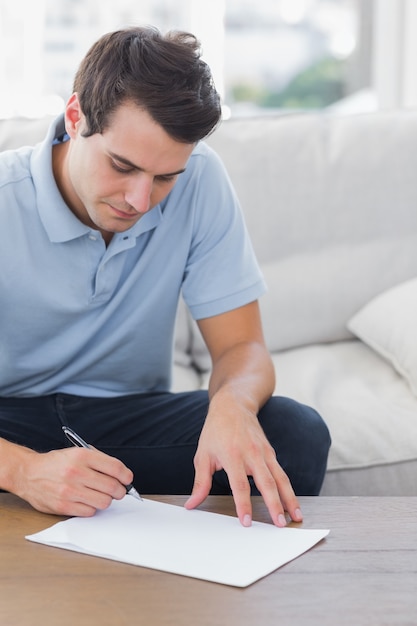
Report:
0,440,133,517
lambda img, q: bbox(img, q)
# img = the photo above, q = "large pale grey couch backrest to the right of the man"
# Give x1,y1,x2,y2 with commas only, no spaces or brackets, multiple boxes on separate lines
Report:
209,110,417,349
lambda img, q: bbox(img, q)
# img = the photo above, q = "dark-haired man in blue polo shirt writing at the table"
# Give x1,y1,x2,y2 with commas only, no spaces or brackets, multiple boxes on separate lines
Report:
0,28,330,526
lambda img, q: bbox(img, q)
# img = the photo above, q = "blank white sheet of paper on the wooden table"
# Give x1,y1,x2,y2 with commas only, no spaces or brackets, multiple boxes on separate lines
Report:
26,496,329,587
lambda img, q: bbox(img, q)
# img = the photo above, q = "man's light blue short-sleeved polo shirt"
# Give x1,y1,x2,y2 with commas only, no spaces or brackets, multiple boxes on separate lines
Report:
0,118,264,397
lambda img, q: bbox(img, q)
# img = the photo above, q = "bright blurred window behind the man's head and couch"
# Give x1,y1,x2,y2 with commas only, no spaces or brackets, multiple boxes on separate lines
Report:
0,0,417,117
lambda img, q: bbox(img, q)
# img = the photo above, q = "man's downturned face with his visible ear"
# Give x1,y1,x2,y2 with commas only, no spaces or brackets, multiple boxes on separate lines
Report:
54,95,194,241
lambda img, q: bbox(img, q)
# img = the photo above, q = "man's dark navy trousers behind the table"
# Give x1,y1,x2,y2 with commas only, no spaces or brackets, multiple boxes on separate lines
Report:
0,391,330,495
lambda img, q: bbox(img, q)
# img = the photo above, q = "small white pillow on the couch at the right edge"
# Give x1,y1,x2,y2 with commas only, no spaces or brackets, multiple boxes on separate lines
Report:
348,279,417,396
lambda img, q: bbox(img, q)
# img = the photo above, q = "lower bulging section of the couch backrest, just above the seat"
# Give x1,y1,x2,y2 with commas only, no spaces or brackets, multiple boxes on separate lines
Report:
260,235,417,352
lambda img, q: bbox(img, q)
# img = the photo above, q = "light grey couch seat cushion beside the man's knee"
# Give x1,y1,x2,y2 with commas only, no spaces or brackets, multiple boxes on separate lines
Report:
274,340,417,495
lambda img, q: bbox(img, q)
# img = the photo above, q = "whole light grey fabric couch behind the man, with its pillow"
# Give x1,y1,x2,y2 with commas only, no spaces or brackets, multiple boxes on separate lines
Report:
0,110,417,495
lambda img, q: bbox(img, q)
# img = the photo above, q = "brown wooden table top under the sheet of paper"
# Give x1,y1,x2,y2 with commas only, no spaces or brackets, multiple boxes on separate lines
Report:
0,494,417,626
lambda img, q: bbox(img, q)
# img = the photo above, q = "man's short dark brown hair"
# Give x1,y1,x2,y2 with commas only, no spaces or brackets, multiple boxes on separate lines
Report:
74,27,221,143
